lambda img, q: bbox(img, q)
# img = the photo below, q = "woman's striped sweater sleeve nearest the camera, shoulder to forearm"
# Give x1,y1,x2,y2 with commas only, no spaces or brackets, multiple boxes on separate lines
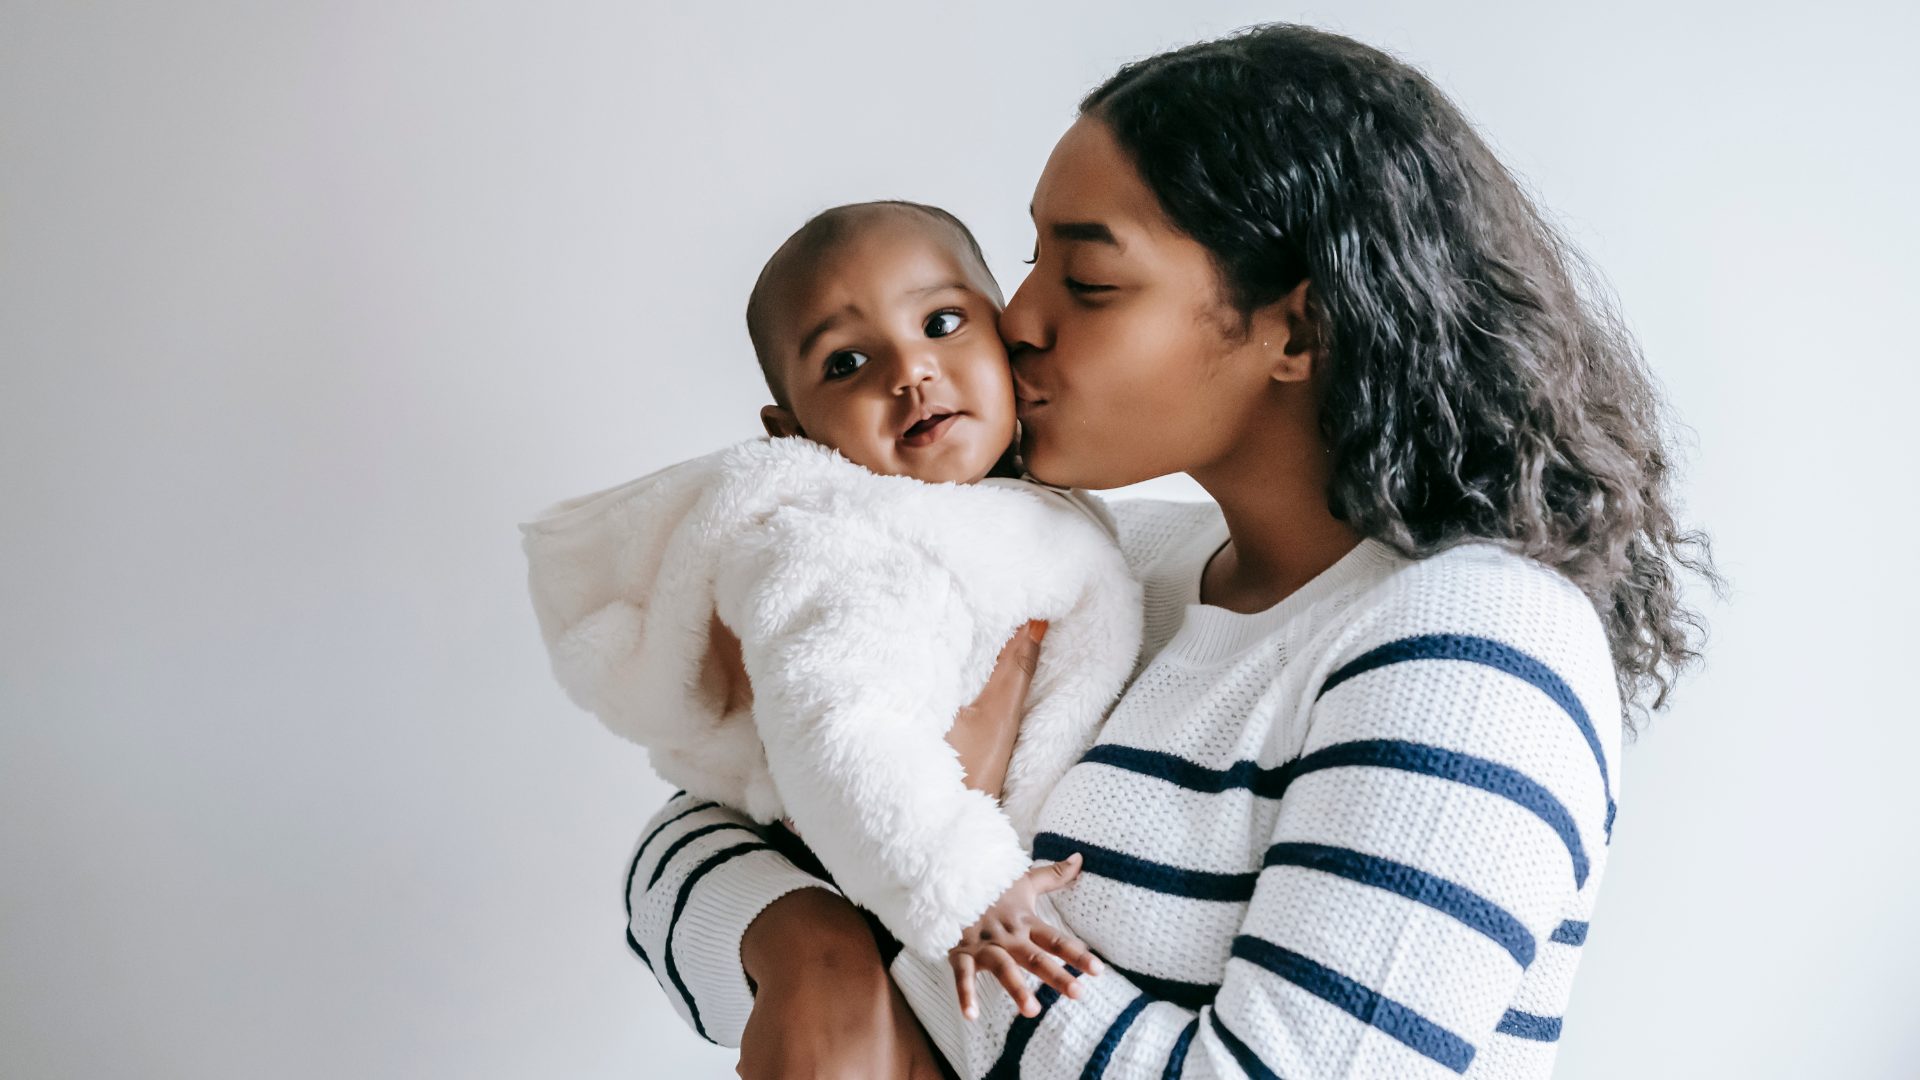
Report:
895,553,1619,1080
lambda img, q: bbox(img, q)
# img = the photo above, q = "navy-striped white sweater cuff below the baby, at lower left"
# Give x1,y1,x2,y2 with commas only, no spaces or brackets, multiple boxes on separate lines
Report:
626,792,833,1045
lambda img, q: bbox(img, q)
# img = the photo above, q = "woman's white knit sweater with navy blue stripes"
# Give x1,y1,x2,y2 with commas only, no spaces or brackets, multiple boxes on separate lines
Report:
628,503,1619,1080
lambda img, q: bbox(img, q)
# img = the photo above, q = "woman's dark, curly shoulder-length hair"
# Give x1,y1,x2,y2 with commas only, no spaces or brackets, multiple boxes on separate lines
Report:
1081,25,1718,726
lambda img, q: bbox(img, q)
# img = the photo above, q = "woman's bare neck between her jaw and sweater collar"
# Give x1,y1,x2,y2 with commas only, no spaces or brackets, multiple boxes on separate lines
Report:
1192,407,1361,613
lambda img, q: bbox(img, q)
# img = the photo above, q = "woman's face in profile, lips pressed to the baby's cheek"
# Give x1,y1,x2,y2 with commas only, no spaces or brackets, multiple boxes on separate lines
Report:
1000,117,1281,488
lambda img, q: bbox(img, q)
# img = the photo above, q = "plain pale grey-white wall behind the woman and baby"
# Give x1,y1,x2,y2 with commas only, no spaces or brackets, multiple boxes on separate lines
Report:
0,0,1920,1080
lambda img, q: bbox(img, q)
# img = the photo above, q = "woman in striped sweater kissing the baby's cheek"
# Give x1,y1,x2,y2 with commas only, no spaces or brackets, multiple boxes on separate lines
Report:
630,25,1711,1080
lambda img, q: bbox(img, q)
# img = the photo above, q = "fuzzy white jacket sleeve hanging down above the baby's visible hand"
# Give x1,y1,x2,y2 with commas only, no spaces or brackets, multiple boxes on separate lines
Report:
714,507,1027,955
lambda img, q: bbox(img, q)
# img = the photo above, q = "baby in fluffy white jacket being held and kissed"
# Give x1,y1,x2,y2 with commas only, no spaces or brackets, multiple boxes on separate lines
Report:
522,202,1140,963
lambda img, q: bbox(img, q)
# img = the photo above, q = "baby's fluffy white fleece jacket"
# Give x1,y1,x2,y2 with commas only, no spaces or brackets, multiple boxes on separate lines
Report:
520,438,1140,955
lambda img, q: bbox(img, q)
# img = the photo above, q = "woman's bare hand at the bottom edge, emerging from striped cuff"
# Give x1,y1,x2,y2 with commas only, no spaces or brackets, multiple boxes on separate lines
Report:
737,888,941,1080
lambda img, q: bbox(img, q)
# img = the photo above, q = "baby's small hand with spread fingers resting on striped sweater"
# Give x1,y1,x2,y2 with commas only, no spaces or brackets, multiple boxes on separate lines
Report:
947,853,1100,1020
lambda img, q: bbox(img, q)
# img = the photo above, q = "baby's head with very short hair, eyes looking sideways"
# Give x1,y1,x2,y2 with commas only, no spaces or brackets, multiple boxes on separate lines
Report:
747,202,1014,484
